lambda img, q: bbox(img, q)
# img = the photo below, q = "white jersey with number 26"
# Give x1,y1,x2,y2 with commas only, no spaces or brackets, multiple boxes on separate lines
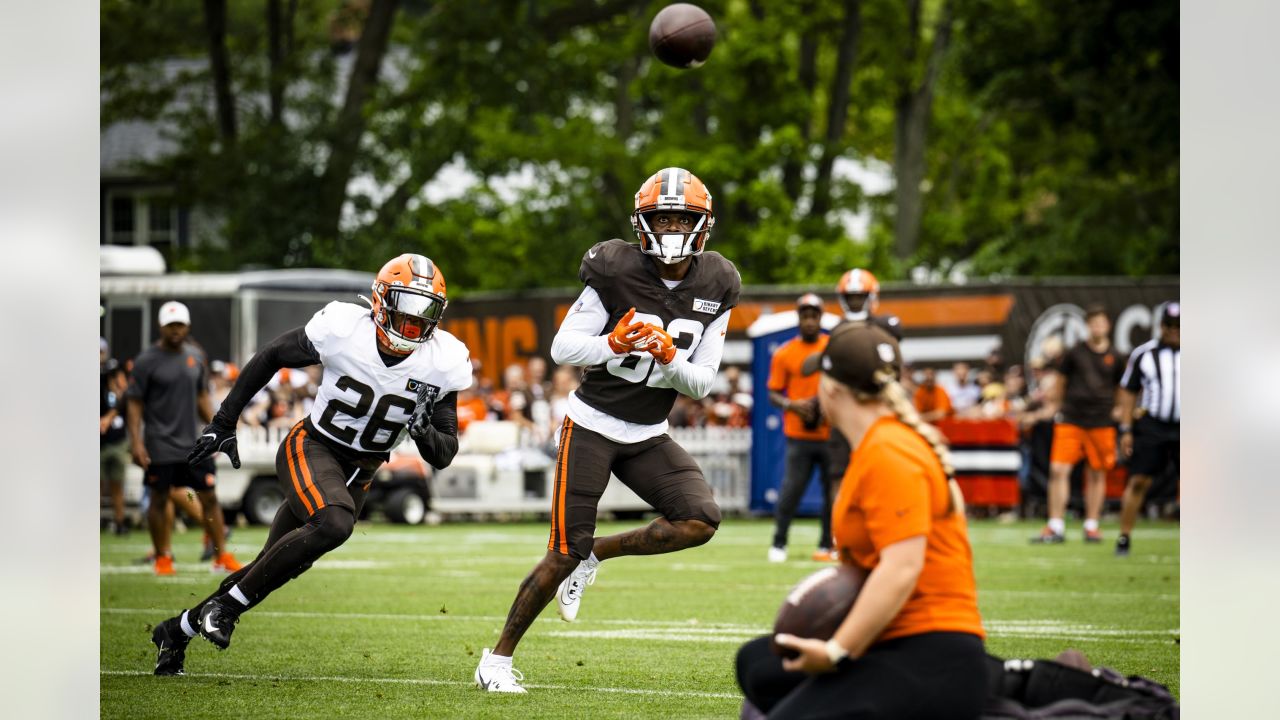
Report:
306,302,471,452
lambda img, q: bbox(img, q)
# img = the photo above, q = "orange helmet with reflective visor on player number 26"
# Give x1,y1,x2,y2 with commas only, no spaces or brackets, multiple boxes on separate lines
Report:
370,252,449,354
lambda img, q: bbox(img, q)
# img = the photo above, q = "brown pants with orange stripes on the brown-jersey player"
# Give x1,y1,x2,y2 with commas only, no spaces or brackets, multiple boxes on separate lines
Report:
547,418,721,560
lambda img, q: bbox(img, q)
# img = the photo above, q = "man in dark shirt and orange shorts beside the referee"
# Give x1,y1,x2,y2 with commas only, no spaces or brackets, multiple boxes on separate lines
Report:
1032,299,1124,543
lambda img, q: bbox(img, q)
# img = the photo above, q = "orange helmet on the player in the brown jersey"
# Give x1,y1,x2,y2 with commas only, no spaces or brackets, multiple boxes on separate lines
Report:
631,168,716,265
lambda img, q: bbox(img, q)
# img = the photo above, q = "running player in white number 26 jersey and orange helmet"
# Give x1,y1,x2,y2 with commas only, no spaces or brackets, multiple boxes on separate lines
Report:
151,254,471,675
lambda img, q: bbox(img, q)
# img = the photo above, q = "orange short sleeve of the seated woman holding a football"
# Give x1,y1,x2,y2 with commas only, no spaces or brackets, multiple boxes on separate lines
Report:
859,445,932,552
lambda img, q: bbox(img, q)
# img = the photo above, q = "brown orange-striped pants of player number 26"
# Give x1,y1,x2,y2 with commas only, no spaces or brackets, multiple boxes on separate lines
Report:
275,420,381,520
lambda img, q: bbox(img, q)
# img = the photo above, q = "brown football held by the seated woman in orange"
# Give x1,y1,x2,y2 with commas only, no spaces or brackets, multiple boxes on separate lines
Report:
769,565,867,657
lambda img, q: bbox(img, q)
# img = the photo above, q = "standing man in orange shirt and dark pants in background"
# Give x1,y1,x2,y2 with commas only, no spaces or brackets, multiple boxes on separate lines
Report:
768,292,835,562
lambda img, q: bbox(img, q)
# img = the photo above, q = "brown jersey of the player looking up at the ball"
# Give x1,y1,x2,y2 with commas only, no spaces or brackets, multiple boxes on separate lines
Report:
577,238,742,425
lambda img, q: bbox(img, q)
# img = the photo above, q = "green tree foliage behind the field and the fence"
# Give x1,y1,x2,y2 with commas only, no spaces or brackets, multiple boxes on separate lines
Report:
102,0,1179,285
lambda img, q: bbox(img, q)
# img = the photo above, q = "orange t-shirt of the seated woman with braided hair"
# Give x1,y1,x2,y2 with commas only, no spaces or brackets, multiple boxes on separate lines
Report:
831,415,986,642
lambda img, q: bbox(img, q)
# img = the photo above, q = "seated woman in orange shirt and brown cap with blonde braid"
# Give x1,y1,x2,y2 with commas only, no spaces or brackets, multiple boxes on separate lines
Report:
737,324,987,720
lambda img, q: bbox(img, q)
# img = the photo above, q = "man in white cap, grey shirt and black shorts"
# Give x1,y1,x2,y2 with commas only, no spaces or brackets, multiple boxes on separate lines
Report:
125,301,239,575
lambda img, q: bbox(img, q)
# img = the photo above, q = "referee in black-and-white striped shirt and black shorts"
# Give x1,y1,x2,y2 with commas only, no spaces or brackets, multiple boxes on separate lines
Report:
1116,302,1183,556
